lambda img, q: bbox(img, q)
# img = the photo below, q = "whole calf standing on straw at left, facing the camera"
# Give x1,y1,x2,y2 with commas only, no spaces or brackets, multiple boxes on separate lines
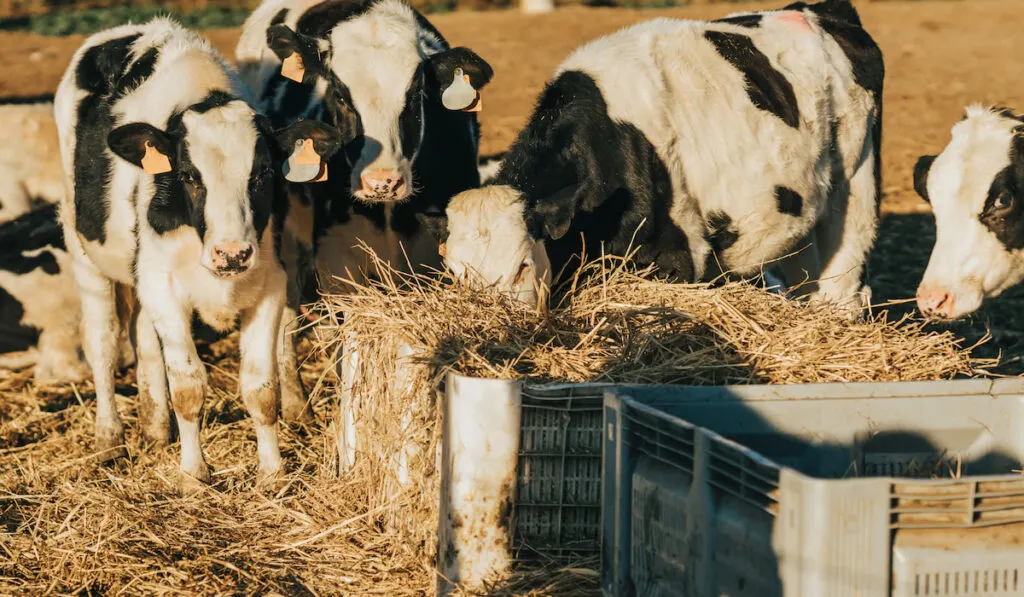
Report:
54,18,345,489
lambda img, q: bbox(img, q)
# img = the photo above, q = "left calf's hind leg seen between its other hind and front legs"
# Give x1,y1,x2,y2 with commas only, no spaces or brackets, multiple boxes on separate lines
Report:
132,305,171,445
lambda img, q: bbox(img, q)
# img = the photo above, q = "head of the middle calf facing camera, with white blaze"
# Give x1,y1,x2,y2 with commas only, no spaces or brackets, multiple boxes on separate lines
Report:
267,0,493,202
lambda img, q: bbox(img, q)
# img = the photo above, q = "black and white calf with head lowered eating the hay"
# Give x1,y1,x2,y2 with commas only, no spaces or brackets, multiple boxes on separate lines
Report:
443,0,884,307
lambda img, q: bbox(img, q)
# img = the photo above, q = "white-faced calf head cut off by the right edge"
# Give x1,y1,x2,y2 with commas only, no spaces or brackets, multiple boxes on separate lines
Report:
913,106,1024,318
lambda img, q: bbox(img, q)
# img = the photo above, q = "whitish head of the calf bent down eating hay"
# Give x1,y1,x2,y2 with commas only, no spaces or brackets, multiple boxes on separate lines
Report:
441,186,551,305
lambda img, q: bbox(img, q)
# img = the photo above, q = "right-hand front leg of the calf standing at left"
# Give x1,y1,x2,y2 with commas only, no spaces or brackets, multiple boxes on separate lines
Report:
239,280,285,480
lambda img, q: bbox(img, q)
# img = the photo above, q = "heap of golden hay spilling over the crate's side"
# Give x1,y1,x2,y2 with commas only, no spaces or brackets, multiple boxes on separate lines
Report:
322,249,977,585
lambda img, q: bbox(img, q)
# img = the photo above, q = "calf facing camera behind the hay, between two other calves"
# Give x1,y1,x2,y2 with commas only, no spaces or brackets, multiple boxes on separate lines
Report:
236,0,492,282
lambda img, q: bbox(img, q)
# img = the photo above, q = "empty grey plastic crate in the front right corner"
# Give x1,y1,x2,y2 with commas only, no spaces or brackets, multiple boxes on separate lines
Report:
602,380,1024,597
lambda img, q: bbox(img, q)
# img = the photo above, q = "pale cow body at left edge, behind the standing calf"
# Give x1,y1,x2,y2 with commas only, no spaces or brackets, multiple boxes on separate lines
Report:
0,95,65,223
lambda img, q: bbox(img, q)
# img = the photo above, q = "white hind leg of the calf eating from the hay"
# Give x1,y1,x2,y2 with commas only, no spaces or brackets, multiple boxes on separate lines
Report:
813,133,880,315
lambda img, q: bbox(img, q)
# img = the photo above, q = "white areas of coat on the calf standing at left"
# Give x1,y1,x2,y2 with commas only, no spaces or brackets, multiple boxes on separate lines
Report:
54,18,285,480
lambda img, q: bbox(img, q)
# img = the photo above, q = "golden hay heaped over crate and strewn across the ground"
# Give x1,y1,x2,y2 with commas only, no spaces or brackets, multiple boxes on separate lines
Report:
0,253,987,596
